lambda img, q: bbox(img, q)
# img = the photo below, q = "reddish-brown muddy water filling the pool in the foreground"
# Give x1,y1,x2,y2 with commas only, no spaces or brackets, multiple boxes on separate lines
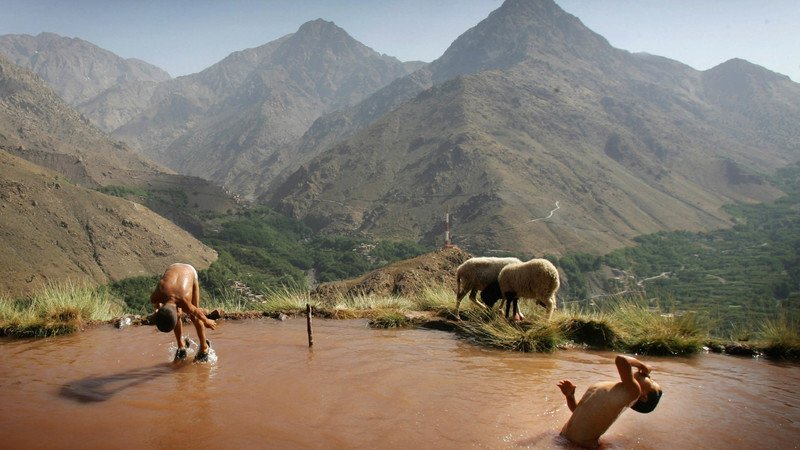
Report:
0,319,800,449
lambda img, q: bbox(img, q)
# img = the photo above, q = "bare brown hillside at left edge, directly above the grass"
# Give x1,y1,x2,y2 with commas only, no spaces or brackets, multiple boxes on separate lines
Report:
0,150,217,298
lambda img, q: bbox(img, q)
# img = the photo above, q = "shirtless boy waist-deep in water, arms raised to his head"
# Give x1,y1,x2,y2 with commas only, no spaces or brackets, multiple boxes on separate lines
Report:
558,355,661,448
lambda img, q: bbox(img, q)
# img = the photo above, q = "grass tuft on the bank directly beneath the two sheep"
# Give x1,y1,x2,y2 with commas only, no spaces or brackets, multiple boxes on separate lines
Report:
459,309,565,352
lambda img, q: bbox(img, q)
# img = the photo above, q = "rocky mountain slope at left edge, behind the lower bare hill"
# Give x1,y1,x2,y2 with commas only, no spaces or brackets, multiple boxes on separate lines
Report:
0,53,234,216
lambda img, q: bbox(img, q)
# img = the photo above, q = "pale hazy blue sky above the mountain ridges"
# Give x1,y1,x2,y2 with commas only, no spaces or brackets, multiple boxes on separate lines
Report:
0,0,800,82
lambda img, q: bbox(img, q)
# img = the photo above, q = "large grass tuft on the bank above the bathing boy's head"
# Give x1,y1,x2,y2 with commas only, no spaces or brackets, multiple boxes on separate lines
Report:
608,297,709,356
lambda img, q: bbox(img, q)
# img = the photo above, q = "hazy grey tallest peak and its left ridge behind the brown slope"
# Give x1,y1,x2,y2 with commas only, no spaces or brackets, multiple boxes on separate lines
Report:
256,1,618,193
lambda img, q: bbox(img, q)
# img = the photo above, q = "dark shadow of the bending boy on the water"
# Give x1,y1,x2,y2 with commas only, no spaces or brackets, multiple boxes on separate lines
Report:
59,363,180,403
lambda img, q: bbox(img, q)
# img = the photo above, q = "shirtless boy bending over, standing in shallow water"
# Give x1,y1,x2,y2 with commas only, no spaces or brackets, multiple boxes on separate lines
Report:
150,263,220,361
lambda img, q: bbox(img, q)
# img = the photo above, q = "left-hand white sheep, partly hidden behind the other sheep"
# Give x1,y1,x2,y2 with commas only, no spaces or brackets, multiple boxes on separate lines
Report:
456,256,522,319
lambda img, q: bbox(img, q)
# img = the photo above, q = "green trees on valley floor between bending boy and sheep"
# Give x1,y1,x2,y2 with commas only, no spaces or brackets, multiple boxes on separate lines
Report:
201,206,425,295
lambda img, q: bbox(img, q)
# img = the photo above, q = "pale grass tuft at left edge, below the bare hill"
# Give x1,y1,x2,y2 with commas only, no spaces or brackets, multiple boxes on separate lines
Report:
0,282,124,337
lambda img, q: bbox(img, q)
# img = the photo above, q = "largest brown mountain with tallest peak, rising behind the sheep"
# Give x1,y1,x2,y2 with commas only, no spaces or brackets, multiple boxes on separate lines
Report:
261,0,800,255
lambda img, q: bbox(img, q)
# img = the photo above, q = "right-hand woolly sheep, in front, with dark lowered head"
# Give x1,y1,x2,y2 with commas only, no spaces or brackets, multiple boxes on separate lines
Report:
497,258,561,320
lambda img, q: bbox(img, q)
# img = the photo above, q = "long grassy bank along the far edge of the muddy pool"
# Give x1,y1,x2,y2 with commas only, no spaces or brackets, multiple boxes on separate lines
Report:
0,284,800,359
